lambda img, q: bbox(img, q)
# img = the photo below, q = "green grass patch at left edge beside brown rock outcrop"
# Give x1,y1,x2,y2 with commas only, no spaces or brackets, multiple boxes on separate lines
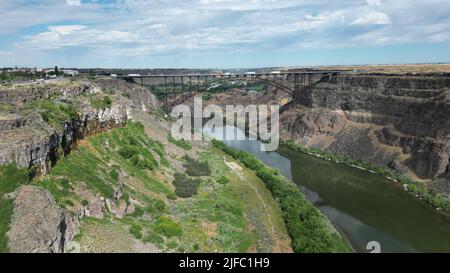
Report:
0,163,30,253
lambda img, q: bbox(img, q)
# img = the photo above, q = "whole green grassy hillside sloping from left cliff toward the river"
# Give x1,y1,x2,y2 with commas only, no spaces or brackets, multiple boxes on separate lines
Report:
22,122,289,252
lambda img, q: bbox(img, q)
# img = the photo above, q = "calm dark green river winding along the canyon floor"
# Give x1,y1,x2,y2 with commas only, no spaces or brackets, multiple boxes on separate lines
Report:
208,124,450,252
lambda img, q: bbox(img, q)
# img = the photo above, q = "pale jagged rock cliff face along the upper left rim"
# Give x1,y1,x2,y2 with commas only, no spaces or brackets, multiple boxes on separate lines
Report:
0,79,130,173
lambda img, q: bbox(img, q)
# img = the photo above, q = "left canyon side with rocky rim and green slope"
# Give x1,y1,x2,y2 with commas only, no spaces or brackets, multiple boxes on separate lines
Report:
0,78,292,253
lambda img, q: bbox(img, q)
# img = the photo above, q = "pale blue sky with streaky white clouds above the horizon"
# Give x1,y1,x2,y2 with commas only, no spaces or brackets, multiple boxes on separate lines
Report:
0,0,450,68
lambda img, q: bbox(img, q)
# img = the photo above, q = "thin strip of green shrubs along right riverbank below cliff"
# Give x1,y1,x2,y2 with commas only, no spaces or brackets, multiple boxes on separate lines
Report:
282,140,450,213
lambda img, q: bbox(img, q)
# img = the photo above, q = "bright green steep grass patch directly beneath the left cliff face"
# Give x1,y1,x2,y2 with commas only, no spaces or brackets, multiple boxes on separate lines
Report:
36,122,173,210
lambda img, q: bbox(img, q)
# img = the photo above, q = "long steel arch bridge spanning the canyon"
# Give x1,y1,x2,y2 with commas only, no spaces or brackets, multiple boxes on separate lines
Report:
117,71,343,112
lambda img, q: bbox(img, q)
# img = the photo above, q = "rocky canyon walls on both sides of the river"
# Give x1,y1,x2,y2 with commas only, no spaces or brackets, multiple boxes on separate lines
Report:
0,67,450,252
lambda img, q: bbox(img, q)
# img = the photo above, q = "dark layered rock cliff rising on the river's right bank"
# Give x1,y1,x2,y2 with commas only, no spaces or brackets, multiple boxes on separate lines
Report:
281,74,450,191
